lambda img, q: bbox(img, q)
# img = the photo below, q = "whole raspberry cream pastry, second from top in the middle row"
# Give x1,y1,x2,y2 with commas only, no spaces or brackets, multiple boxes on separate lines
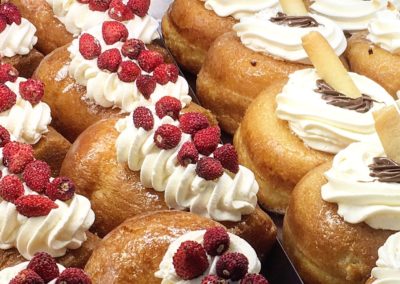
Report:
35,21,191,141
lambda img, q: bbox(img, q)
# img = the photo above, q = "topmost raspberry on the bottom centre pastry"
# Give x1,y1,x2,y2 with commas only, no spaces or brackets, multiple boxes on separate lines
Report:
203,227,230,256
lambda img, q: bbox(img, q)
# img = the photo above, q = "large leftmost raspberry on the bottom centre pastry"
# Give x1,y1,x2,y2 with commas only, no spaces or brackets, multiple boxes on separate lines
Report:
172,241,209,280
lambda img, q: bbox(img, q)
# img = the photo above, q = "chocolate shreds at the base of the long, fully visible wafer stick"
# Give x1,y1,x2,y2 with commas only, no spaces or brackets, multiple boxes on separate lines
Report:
315,80,376,113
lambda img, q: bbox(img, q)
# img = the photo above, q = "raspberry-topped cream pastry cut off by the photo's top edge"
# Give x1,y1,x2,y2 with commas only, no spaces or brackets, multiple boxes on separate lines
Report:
9,0,158,54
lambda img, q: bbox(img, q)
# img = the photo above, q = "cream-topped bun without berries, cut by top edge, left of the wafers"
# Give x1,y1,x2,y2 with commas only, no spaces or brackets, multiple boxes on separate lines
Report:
162,0,279,74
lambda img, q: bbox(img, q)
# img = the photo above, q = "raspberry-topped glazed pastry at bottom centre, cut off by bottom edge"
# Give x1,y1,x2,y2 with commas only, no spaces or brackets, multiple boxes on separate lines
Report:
85,211,268,284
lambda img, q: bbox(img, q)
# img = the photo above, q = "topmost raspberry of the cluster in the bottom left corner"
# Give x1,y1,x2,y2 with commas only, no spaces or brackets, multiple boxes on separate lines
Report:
28,252,60,283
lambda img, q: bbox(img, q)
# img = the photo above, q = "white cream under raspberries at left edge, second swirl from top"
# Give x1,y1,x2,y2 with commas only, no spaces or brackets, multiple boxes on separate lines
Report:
0,77,51,144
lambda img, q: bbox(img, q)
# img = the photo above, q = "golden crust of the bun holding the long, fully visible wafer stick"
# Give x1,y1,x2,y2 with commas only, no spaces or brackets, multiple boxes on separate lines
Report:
234,83,332,213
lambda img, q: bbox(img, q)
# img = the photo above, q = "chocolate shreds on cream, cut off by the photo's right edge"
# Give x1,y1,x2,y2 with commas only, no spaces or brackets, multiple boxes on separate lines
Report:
368,157,400,183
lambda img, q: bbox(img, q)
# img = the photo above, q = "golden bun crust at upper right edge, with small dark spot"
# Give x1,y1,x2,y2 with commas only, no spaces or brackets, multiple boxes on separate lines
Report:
346,32,400,97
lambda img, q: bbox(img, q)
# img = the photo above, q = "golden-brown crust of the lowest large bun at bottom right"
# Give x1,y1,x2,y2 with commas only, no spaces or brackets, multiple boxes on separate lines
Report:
283,163,393,284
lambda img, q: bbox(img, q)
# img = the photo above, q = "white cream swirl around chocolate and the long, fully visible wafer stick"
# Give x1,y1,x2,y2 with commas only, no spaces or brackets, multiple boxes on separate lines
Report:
276,69,393,154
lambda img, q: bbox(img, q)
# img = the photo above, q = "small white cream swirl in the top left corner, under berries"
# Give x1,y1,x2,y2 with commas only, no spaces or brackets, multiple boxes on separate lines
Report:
0,18,38,57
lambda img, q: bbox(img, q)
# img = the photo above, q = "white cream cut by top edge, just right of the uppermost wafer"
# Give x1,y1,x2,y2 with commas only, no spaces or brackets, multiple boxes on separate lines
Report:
310,0,388,32
